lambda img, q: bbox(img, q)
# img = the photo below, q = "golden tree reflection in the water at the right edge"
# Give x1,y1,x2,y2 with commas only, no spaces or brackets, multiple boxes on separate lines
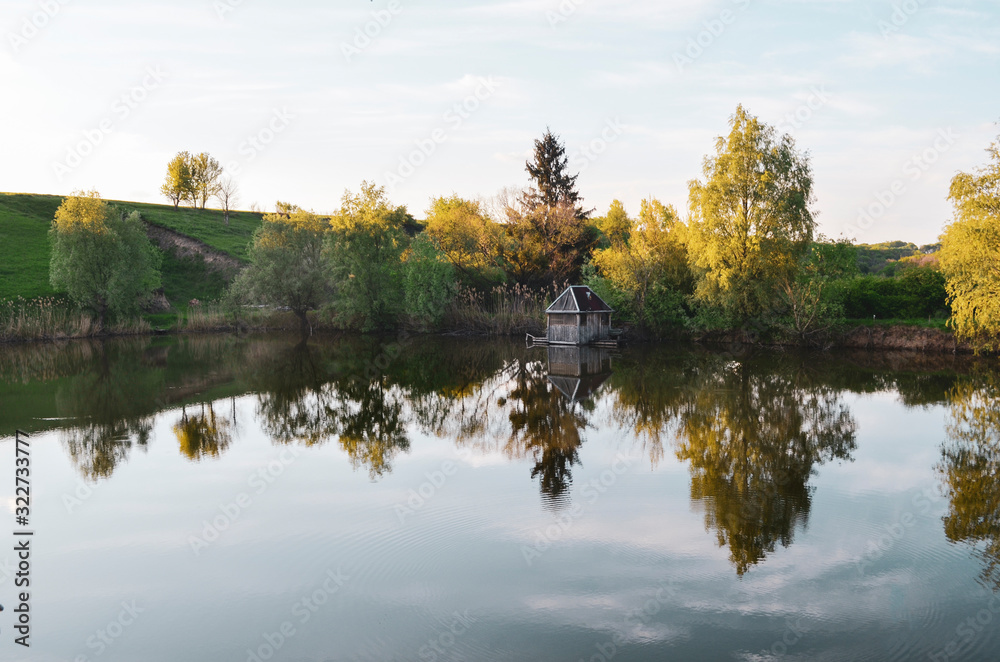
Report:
937,372,1000,590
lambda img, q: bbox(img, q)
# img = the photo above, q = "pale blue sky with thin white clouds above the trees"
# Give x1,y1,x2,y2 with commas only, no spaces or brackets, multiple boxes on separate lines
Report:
0,0,1000,244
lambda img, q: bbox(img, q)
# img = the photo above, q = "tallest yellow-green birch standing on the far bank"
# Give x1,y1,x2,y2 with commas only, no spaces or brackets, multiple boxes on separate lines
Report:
689,106,815,323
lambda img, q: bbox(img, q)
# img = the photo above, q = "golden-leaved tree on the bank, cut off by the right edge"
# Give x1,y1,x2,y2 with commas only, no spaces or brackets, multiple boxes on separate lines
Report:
940,138,1000,350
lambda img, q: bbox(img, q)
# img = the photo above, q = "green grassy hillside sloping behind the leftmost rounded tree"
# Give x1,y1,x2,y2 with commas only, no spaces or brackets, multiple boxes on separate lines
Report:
0,193,261,309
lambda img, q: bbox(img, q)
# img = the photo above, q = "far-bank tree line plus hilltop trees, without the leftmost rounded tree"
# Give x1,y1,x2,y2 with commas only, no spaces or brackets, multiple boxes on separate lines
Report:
53,106,1000,348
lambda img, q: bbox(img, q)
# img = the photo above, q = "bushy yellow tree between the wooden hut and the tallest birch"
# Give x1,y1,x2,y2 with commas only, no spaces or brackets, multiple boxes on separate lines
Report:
594,198,691,330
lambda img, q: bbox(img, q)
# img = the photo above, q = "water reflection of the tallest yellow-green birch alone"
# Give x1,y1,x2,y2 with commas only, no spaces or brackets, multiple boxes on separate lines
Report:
676,362,857,575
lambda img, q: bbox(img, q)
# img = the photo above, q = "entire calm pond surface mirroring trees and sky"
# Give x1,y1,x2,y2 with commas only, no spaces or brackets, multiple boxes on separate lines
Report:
0,337,1000,662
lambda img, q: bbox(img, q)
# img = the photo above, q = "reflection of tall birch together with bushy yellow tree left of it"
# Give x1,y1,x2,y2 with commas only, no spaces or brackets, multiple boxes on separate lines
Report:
612,353,857,576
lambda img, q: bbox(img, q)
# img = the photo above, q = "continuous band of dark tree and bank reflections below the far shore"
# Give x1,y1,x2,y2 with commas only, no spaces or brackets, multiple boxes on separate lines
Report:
7,336,1000,586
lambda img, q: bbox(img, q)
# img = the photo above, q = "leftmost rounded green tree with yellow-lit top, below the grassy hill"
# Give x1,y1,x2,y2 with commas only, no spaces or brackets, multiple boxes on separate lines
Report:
49,191,162,328
